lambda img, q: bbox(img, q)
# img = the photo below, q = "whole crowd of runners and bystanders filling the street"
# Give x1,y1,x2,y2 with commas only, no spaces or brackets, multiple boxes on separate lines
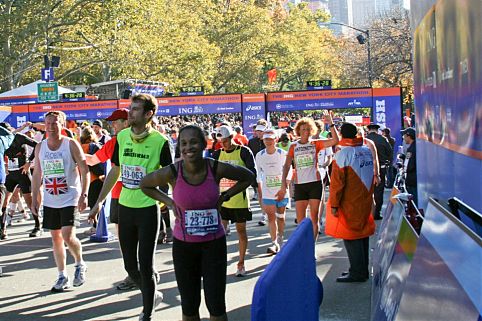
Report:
0,94,416,320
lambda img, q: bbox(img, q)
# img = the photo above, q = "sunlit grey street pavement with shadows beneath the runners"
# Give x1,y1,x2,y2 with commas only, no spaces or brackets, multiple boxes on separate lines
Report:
0,192,389,321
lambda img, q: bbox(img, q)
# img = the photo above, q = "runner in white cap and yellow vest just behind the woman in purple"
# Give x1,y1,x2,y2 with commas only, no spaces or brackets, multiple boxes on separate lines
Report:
213,126,256,276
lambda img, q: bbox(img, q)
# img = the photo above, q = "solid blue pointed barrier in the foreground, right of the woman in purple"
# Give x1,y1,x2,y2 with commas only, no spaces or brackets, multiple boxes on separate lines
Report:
251,219,323,321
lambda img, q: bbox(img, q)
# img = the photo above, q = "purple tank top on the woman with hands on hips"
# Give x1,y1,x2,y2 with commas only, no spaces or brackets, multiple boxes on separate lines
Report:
172,159,224,243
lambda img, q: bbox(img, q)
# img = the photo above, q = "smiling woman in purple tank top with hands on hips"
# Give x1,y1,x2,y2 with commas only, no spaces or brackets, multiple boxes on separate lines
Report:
141,125,255,320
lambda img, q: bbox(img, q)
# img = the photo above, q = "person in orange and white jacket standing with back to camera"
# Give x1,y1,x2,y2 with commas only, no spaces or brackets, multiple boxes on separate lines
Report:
325,123,375,282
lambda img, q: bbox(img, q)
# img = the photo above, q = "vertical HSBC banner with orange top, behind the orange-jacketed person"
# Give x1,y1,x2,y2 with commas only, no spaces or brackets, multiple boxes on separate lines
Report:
372,87,403,158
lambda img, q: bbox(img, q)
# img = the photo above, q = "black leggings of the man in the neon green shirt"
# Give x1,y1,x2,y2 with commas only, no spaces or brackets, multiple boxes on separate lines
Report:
119,204,159,317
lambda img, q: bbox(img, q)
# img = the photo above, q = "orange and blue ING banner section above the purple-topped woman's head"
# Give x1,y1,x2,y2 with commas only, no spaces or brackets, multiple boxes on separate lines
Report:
157,94,241,116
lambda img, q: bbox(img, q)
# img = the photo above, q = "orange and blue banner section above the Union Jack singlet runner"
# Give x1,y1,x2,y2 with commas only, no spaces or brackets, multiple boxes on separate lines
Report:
28,100,117,122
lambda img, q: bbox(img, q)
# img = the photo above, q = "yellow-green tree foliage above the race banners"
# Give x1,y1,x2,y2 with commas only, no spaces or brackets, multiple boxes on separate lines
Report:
0,0,343,93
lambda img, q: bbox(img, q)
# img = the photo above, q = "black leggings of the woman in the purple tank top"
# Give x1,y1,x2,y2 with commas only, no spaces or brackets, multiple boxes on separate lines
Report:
172,236,227,316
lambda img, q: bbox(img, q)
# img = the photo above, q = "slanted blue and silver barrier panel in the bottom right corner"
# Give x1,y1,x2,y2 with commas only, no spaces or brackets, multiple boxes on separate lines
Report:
396,198,482,321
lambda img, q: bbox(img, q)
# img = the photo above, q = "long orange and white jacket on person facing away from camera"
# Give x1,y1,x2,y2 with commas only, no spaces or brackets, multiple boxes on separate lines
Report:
325,139,375,240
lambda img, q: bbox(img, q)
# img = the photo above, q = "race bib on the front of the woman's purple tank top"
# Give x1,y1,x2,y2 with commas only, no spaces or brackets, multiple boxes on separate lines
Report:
184,209,219,236
